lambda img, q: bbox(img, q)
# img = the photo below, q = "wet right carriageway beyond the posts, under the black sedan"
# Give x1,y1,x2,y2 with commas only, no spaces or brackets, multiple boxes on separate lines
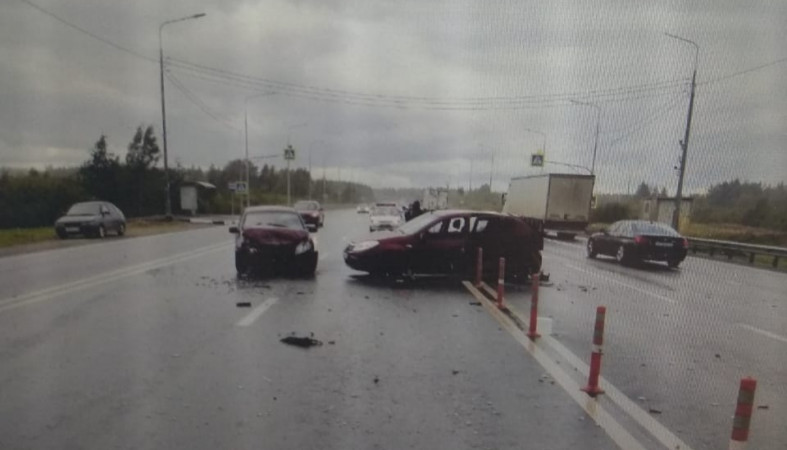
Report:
502,237,787,449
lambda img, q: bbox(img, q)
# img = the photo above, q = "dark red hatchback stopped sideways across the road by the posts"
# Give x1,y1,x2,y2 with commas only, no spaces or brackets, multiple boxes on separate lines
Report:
344,210,543,279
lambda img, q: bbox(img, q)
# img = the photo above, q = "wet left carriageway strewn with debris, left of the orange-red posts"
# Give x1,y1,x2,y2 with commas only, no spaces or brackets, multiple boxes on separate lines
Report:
0,211,620,449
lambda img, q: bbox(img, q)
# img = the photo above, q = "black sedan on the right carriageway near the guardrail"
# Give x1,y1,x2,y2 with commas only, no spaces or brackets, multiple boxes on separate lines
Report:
587,220,689,268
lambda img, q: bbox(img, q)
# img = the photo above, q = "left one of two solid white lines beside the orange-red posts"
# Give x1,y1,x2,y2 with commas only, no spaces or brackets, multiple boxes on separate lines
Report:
462,281,645,450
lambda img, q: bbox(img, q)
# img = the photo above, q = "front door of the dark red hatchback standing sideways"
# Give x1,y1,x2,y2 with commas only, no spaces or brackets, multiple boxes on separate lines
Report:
412,215,469,274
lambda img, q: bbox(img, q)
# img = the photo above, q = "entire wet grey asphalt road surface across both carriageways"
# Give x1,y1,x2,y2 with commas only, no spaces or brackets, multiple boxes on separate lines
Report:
0,211,787,449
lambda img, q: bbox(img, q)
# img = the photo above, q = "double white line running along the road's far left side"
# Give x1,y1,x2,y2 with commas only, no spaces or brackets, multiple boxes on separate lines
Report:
0,243,229,313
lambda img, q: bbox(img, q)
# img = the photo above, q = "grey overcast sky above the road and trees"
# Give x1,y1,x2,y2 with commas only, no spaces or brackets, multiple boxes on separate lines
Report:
0,0,787,193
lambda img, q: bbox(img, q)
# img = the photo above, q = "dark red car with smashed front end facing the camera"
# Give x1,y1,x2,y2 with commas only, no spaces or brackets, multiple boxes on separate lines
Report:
230,206,318,275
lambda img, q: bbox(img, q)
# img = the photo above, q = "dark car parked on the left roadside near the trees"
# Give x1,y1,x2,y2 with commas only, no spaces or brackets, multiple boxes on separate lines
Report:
55,201,126,239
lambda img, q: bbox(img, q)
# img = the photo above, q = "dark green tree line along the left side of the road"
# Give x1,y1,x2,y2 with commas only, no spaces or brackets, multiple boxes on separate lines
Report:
0,126,374,228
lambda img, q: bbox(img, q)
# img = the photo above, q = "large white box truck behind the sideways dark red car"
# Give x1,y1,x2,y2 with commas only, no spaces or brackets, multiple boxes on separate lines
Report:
503,173,595,239
